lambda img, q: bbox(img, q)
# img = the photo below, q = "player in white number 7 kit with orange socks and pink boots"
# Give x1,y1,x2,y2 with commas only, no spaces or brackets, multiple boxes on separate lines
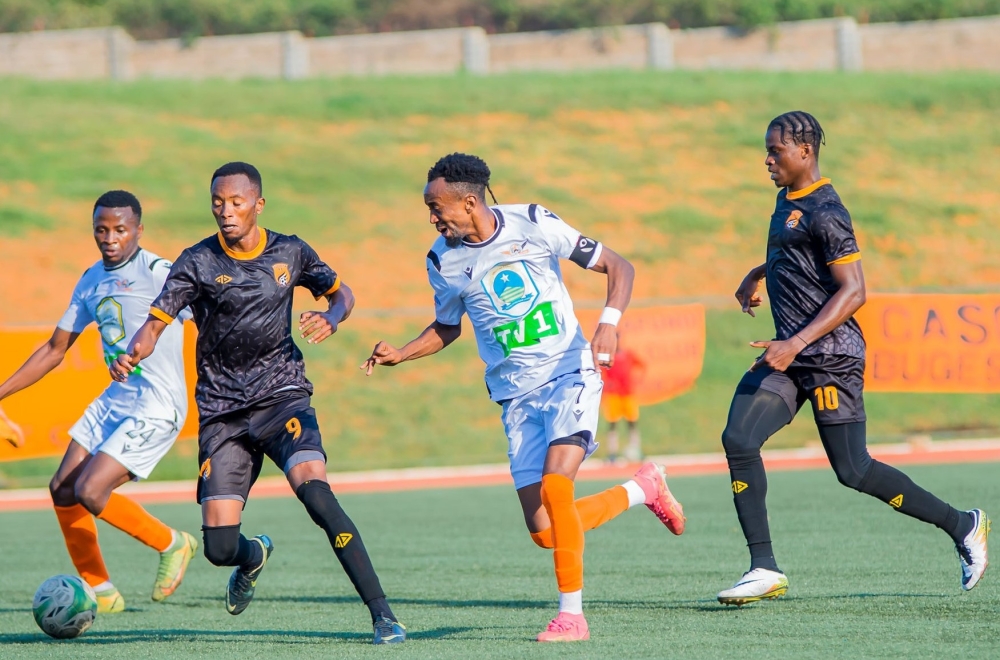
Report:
362,154,685,642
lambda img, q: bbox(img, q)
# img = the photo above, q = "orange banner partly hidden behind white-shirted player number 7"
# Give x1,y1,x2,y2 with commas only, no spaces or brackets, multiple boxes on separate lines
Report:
577,304,705,405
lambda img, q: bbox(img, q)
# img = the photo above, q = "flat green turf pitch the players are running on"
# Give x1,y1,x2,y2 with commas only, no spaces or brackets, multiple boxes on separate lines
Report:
0,464,1000,660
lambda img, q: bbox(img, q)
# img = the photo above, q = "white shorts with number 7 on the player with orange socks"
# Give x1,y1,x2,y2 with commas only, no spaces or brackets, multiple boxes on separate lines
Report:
502,369,604,488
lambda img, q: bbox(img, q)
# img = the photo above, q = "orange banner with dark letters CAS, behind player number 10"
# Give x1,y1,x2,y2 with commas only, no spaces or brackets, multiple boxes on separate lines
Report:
856,294,1000,393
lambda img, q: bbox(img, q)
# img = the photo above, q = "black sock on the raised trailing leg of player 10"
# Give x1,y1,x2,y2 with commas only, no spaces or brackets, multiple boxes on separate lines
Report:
858,460,972,543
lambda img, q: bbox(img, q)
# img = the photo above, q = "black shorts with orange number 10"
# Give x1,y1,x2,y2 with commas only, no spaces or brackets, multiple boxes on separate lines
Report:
737,355,867,426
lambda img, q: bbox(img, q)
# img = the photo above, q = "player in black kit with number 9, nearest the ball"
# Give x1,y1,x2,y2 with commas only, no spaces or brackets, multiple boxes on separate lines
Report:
110,163,406,644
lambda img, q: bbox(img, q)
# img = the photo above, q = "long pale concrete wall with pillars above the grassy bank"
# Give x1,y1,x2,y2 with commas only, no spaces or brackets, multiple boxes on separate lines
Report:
0,16,1000,80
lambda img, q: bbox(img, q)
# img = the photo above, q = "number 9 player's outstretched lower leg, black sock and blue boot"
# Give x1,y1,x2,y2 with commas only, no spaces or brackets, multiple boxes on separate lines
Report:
286,460,406,644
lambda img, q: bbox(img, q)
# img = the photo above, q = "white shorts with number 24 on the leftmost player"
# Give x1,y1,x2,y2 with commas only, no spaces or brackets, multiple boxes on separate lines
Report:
69,394,184,479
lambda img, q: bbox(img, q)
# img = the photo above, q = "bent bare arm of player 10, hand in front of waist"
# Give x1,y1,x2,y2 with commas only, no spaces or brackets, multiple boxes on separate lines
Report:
750,260,867,371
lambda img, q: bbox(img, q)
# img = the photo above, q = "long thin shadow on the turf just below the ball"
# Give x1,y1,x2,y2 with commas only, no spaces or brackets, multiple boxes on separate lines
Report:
0,627,474,645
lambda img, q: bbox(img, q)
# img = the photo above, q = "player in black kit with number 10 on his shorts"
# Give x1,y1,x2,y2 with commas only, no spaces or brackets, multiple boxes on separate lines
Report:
718,112,990,605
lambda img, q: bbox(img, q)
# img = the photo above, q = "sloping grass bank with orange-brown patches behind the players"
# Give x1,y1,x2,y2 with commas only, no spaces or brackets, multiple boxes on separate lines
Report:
0,71,1000,486
